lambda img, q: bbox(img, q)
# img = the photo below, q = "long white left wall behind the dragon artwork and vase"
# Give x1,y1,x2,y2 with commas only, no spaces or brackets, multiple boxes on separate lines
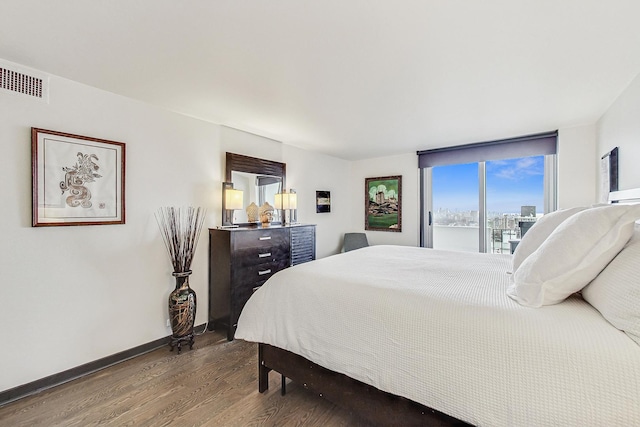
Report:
0,61,351,391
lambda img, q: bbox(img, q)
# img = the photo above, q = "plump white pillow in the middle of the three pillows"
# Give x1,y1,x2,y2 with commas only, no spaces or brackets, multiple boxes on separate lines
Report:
507,205,640,307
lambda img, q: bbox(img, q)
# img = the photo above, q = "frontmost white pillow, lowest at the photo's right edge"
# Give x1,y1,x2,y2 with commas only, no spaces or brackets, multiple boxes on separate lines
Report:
582,225,640,345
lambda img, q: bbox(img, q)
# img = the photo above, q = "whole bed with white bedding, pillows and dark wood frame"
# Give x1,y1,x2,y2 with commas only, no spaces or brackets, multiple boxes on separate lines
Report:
236,195,640,426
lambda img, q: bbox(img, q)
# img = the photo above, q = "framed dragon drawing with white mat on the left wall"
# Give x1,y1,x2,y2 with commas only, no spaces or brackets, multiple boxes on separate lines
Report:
31,128,125,227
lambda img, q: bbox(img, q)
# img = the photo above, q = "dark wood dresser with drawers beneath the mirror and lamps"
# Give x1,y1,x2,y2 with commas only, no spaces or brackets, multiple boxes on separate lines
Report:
209,224,316,341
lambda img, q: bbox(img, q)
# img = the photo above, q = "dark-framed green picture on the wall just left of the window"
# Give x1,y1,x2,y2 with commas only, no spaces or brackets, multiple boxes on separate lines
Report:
364,175,402,232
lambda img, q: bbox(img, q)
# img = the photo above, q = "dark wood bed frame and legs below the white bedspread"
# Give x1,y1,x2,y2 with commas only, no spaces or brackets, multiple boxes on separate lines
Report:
258,343,469,426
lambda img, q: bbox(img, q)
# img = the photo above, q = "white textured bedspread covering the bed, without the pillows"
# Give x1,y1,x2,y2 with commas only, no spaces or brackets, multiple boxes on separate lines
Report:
235,246,640,426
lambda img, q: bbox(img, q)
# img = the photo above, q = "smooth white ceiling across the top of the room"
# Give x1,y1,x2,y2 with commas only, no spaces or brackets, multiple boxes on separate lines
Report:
0,0,640,160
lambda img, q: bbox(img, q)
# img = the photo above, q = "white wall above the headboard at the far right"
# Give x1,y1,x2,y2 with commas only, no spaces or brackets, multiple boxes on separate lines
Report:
595,75,640,201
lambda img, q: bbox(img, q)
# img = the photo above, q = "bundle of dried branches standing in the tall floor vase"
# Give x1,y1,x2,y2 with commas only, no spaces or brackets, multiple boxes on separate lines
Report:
156,206,206,273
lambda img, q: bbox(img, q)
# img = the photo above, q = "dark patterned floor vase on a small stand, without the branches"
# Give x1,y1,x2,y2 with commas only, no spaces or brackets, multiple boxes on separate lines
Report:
169,270,196,353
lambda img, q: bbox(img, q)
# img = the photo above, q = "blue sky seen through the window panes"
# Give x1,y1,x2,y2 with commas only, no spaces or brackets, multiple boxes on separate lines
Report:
433,156,544,213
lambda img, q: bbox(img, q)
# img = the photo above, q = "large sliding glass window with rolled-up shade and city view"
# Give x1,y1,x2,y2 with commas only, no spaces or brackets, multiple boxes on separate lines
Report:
418,132,557,253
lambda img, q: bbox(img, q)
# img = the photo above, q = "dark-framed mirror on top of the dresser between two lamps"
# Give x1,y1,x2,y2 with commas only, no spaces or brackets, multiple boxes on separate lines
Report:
222,153,286,225
